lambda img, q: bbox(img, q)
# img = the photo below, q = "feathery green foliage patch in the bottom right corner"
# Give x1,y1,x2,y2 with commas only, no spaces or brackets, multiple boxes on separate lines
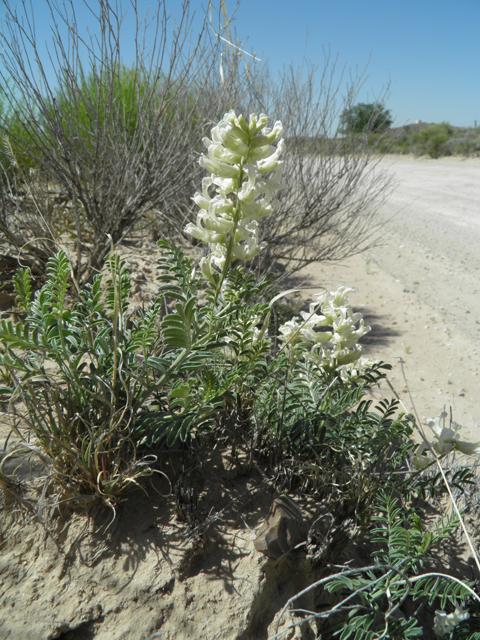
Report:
317,491,475,640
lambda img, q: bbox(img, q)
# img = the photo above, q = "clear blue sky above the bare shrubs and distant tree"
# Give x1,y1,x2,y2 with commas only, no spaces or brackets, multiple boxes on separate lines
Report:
2,0,480,126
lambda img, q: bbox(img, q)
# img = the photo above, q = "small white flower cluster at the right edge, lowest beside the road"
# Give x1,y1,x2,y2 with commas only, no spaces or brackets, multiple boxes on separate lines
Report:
411,411,480,469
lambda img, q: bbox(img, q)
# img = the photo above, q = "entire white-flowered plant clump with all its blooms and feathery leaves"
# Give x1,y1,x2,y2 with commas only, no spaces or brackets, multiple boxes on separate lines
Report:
0,111,480,638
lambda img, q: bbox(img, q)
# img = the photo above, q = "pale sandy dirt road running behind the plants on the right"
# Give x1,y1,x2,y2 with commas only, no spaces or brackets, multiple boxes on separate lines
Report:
298,156,480,441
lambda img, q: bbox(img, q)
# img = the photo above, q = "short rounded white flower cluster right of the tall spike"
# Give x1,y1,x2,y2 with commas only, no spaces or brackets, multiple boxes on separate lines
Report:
280,286,372,380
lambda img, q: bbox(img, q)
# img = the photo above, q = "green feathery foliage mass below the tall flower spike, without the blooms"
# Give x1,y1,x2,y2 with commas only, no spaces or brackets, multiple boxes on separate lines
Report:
0,243,424,520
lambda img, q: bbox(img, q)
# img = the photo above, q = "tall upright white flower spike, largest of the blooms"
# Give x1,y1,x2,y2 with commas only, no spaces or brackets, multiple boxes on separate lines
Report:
185,111,284,282
